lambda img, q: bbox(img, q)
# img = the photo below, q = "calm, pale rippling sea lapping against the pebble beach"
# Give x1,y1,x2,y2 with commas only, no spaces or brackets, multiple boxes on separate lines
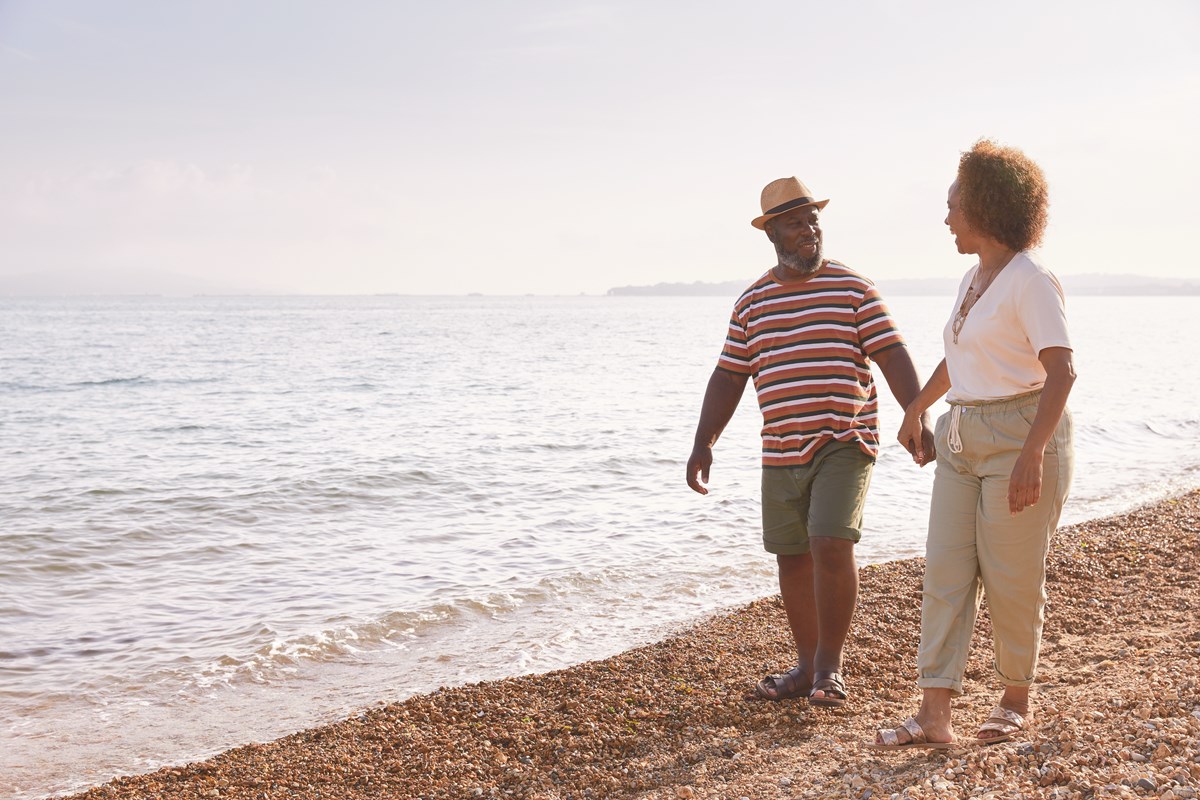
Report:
7,296,1200,800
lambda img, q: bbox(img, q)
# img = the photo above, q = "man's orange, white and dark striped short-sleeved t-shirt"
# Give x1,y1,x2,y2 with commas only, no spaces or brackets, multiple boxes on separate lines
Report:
718,261,904,467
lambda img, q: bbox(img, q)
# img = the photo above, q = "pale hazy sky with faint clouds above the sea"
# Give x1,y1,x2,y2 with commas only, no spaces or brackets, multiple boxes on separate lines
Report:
0,0,1200,294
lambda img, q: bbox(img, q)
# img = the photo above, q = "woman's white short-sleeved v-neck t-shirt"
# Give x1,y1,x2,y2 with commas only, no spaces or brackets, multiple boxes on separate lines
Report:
942,251,1070,403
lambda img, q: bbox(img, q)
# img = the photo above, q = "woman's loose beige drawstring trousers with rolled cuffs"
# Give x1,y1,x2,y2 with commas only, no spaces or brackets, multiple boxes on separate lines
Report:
917,392,1074,694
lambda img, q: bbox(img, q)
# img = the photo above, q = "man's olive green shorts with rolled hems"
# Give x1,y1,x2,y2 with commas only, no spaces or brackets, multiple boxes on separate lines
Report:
762,441,875,555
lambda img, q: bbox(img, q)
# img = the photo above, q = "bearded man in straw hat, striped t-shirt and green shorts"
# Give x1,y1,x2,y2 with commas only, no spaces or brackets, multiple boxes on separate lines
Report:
688,178,934,706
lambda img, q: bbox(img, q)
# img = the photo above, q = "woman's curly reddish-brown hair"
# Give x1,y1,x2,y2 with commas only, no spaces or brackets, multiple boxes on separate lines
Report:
958,139,1050,251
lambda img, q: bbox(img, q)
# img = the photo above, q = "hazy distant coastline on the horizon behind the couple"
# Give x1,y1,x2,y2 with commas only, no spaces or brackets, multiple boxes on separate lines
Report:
607,275,1200,297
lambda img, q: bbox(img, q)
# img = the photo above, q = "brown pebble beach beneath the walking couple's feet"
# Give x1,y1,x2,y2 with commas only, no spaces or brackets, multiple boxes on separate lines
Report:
60,491,1200,800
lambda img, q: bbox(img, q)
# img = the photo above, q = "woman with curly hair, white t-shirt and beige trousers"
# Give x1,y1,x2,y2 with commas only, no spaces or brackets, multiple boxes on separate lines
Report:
874,140,1075,748
